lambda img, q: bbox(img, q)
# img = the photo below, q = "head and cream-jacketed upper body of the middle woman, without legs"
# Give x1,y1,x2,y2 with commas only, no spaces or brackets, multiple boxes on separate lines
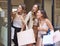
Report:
25,4,39,29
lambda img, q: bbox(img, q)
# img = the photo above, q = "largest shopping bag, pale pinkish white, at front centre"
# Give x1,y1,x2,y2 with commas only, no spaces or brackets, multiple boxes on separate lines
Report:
17,29,35,46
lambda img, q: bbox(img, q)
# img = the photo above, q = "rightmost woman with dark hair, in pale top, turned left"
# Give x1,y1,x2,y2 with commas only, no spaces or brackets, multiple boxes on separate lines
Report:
36,10,54,46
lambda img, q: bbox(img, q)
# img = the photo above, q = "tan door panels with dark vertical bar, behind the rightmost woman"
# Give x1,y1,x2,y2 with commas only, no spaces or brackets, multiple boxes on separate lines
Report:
44,0,60,30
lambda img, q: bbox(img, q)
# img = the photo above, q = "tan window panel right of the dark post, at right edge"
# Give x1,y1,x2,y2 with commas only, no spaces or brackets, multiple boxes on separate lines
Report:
54,0,60,28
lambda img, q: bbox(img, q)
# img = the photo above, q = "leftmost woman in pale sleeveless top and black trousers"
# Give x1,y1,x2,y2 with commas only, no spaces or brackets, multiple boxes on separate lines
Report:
11,4,25,46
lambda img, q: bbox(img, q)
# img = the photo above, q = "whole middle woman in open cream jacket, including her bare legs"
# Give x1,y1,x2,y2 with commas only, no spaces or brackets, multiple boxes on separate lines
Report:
25,4,39,46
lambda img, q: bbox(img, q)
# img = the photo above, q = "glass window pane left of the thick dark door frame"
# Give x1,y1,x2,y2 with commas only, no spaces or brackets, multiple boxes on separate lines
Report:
0,0,8,46
